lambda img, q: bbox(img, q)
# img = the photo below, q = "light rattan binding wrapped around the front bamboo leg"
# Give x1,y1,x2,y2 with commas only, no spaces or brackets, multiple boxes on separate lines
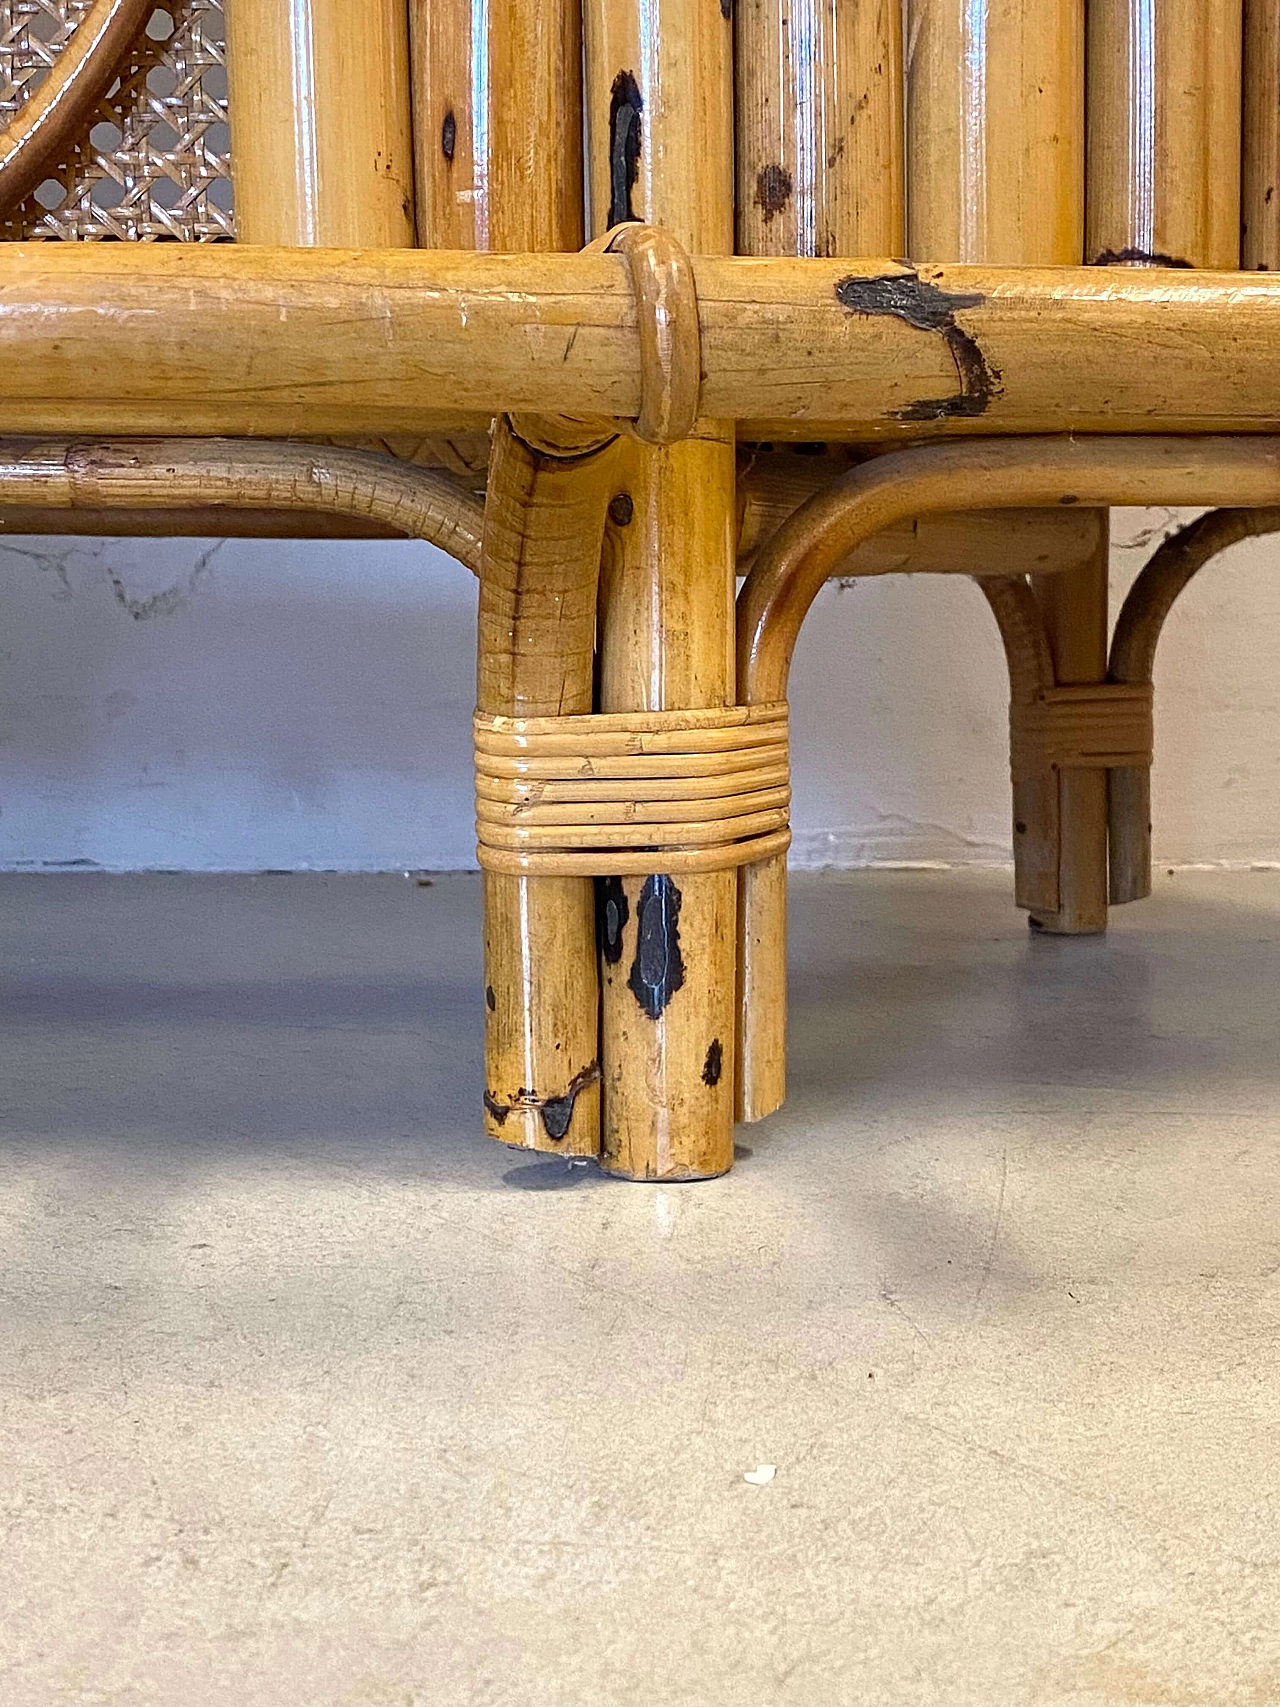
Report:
474,703,790,877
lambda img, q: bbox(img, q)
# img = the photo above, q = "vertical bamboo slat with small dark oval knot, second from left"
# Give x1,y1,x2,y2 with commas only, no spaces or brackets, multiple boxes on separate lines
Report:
410,0,584,251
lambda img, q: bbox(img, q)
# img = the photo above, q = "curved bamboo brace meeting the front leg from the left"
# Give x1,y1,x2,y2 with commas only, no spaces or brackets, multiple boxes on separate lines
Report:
0,439,485,574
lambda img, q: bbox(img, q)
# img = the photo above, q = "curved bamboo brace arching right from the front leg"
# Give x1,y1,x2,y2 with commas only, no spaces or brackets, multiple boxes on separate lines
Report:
737,437,1280,1120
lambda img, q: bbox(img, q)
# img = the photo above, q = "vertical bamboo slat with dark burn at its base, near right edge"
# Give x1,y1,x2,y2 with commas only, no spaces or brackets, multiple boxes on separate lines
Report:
1087,0,1242,268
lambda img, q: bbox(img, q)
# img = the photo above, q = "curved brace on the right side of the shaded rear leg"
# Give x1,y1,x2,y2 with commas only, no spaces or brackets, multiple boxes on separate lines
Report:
1109,505,1280,906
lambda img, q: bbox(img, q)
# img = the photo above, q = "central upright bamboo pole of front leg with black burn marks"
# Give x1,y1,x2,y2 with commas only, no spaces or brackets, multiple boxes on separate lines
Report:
585,0,737,1180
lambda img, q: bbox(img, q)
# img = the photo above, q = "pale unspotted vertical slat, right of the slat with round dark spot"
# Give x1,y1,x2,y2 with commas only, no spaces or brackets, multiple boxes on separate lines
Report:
906,0,1084,265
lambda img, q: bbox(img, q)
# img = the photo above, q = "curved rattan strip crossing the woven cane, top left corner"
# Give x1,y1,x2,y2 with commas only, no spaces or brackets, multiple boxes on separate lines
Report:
0,0,155,215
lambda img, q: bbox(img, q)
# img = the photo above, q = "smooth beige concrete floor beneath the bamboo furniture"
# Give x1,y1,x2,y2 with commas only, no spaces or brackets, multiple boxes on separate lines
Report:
0,874,1280,1707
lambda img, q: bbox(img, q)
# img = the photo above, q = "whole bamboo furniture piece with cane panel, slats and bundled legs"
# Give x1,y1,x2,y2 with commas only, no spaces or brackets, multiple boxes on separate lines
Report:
0,0,1280,1180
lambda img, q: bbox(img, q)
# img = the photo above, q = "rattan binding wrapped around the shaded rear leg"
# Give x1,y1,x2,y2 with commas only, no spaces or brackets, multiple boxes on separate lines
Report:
1010,681,1155,782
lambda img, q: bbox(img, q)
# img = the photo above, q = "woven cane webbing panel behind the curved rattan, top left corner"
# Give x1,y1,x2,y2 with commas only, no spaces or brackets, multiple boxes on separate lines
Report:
0,0,236,242
